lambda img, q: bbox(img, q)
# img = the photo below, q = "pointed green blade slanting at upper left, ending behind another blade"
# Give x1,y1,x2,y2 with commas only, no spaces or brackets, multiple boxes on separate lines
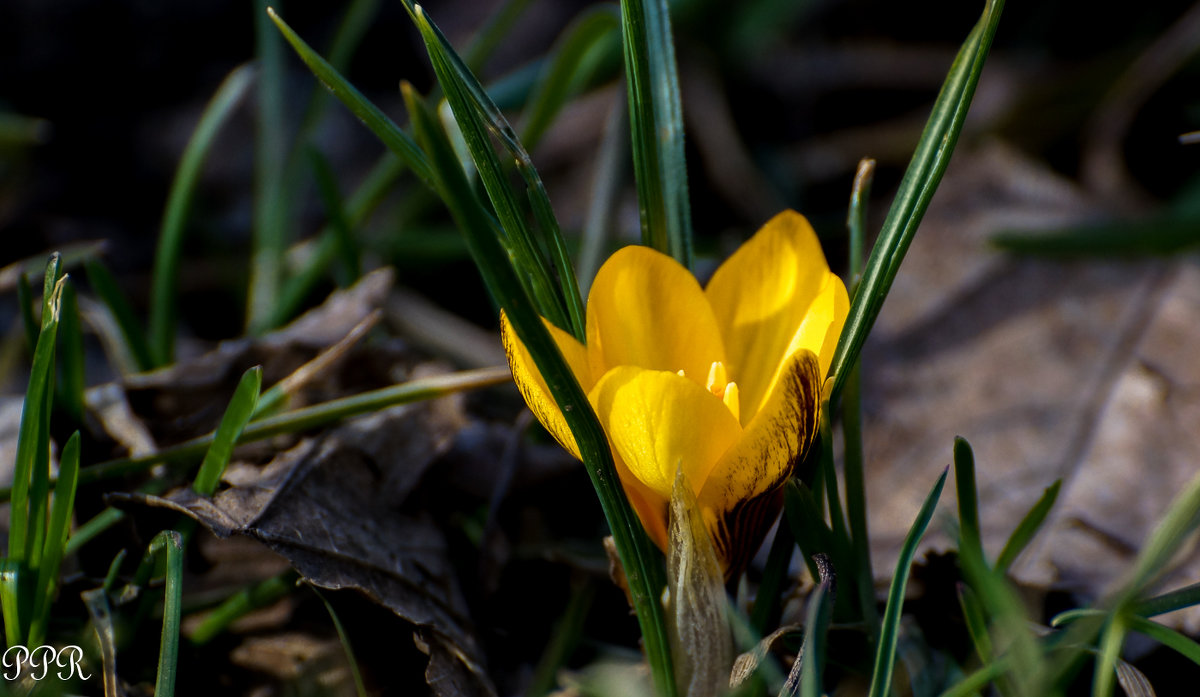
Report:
266,8,433,186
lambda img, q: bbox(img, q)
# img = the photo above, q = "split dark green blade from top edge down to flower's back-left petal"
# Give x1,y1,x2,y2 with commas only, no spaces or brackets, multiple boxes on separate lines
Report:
406,1,584,341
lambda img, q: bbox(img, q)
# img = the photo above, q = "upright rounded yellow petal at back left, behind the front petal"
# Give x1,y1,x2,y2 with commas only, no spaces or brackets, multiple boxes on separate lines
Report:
587,246,725,386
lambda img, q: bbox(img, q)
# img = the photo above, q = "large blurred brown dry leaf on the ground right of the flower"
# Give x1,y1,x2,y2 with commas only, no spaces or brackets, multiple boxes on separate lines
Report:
864,139,1200,629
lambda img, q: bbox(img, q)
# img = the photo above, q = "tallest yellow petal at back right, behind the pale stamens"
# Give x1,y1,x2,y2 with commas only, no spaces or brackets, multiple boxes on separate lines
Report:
700,211,841,423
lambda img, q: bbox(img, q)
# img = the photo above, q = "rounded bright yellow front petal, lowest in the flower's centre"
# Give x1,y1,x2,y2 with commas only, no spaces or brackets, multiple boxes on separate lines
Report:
589,366,742,507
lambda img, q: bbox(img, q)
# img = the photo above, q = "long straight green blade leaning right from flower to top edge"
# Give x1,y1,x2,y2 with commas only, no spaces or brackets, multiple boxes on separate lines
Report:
829,0,1003,403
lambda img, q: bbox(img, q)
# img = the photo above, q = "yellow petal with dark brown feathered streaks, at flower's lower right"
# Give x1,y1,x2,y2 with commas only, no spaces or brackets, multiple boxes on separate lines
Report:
696,350,822,571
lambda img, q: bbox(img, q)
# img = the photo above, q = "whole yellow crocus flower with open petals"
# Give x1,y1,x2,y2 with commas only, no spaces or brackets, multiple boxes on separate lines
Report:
500,211,850,577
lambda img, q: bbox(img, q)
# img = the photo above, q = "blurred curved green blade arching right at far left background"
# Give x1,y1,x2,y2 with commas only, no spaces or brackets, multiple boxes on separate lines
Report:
152,66,254,366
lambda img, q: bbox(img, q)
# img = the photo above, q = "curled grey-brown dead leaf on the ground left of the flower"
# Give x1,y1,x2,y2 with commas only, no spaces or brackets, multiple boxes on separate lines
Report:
116,383,494,695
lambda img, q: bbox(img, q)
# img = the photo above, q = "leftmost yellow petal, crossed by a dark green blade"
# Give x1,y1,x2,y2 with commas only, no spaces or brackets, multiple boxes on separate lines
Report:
500,311,593,457
